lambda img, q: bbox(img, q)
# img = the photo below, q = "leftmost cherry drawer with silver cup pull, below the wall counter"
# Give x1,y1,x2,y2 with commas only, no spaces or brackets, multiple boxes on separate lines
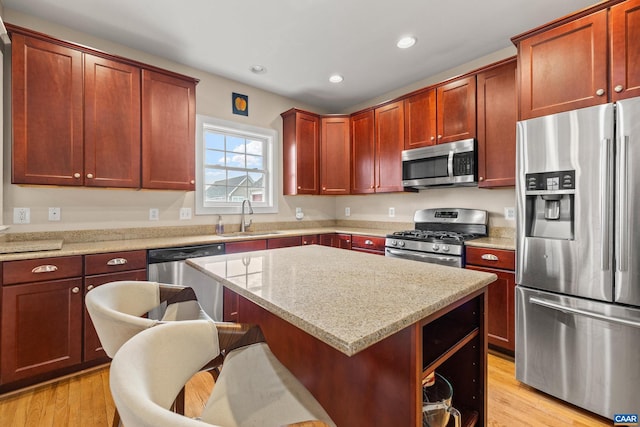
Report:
2,255,82,285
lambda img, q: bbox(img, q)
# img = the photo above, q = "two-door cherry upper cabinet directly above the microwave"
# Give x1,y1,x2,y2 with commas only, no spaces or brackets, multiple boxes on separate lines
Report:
404,75,476,150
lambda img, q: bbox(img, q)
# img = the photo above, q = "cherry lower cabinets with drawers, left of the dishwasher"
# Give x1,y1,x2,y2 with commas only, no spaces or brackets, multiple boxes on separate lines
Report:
0,251,147,391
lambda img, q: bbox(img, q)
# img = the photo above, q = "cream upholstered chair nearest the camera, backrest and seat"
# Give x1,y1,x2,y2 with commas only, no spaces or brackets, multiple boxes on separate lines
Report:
110,320,335,427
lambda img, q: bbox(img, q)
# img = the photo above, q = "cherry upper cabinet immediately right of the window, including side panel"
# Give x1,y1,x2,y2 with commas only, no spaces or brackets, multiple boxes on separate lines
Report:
281,108,320,196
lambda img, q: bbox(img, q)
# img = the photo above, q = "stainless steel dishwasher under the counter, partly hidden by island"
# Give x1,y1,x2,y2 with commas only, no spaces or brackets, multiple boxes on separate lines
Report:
147,243,224,321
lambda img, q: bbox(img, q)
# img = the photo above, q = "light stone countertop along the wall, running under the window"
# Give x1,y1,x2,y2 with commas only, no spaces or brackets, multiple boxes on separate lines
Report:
0,225,397,261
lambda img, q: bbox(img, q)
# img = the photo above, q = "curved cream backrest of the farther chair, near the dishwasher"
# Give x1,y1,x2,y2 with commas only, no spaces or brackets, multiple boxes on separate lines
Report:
85,281,160,358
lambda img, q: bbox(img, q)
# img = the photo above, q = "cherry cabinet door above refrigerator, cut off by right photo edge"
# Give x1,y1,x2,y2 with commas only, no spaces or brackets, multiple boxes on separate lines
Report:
609,0,640,101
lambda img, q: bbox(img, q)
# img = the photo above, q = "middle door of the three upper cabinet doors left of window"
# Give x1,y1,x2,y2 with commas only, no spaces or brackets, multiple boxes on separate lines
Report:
84,54,140,188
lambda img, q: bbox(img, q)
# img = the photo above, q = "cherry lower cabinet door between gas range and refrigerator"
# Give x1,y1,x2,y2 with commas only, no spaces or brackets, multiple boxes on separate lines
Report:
466,266,516,352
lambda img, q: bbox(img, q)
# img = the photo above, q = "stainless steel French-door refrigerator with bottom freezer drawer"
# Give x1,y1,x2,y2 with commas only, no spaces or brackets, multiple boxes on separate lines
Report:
515,98,640,419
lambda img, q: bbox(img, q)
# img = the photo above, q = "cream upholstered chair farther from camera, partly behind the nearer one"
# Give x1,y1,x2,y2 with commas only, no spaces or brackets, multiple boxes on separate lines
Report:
85,281,216,426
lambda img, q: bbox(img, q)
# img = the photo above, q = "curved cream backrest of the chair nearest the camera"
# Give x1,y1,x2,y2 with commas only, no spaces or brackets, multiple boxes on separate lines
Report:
110,320,220,427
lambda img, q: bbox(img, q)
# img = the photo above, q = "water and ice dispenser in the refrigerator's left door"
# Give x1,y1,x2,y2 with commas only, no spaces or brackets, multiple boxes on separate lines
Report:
525,170,576,240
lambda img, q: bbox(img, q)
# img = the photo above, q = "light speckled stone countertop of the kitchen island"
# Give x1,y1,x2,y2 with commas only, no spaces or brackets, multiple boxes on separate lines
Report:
187,245,496,356
